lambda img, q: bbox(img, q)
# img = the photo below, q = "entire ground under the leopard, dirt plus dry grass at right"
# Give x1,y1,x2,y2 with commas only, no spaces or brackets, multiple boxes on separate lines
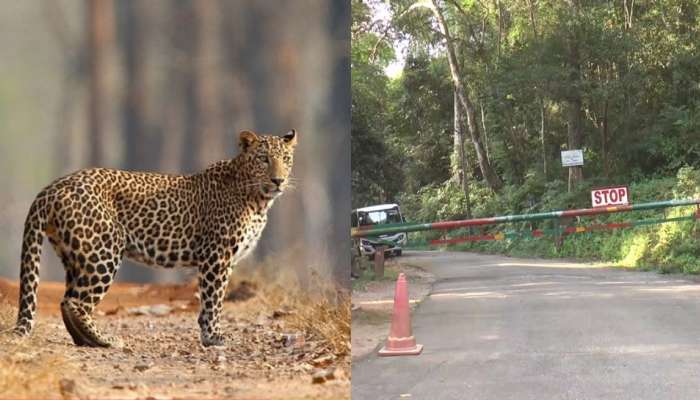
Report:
0,276,350,398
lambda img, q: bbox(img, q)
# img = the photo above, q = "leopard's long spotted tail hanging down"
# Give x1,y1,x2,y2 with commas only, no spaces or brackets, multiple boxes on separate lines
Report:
14,199,47,336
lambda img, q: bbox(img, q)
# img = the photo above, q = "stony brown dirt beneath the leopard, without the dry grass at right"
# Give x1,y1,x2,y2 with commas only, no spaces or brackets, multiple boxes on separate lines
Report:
0,279,350,399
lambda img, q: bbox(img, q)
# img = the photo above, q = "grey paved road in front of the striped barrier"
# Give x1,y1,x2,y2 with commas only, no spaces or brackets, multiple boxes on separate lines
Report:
352,252,700,400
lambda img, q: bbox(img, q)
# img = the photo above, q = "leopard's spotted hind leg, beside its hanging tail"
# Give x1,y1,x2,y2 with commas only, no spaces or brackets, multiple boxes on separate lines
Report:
57,219,124,347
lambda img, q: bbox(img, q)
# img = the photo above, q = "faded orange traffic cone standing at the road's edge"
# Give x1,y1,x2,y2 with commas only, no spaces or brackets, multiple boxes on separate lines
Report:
379,274,423,356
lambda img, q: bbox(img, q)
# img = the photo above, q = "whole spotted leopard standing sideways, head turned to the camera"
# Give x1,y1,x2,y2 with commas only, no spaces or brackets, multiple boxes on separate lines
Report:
13,130,298,348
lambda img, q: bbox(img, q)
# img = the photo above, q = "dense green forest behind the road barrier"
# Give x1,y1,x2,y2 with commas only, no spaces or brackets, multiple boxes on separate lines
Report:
351,0,700,272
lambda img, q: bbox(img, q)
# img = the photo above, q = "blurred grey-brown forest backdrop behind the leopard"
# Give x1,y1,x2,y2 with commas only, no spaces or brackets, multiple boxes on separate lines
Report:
0,0,350,284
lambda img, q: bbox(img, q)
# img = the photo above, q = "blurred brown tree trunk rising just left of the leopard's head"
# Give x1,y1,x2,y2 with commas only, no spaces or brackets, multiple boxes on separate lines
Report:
193,1,226,168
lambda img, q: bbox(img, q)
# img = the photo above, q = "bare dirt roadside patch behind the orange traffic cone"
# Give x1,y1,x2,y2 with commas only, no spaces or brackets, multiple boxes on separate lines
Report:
352,257,435,360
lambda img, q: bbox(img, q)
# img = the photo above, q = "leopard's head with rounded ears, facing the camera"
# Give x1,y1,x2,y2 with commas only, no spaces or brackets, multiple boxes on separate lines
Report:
239,129,298,199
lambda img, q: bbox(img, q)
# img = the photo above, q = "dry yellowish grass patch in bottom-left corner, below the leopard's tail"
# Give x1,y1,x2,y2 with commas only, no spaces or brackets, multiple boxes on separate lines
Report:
0,304,78,399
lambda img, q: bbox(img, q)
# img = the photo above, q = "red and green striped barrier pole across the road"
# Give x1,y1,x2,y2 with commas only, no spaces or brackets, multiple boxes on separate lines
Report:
350,199,700,239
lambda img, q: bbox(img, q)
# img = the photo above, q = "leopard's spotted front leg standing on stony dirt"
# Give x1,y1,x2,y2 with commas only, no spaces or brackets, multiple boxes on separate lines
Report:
197,262,231,346
